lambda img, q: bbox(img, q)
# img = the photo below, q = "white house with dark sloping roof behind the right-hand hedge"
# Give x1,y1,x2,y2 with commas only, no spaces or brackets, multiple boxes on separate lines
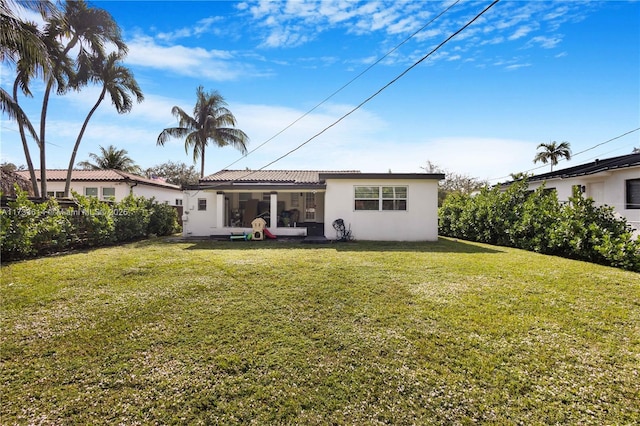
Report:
503,153,640,235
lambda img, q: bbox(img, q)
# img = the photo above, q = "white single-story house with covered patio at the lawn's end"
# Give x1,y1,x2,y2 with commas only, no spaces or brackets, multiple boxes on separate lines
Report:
182,170,444,241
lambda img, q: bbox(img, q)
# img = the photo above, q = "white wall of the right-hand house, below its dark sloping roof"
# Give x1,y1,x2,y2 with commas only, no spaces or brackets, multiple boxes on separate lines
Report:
529,167,640,235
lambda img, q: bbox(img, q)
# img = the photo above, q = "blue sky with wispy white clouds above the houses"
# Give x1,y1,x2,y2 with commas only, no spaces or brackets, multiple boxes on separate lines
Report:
1,0,640,183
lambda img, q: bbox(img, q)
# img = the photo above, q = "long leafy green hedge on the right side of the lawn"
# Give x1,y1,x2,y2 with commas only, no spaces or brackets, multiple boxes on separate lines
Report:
439,181,640,272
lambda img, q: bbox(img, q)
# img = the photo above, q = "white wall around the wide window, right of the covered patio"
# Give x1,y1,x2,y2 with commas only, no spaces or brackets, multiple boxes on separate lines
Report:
324,179,438,241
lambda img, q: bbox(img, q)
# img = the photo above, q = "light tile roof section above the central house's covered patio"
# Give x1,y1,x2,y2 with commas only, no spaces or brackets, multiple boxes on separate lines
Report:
200,170,360,185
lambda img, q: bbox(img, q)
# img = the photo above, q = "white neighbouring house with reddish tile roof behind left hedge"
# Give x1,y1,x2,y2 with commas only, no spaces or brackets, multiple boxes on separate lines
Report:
18,170,182,206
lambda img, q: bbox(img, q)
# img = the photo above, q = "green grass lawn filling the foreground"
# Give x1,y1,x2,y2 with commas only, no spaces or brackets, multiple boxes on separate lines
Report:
0,239,640,425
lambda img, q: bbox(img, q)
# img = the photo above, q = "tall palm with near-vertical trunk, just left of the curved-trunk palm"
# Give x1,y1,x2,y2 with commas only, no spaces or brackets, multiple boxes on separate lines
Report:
39,0,126,198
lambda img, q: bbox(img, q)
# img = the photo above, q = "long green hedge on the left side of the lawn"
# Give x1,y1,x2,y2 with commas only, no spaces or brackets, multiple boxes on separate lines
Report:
0,189,180,260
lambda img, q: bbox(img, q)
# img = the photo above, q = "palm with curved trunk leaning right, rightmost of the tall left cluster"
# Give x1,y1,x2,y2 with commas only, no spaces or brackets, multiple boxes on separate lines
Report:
64,52,144,197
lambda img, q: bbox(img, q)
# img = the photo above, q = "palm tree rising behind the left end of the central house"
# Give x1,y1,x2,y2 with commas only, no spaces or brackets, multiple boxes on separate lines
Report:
157,86,249,178
